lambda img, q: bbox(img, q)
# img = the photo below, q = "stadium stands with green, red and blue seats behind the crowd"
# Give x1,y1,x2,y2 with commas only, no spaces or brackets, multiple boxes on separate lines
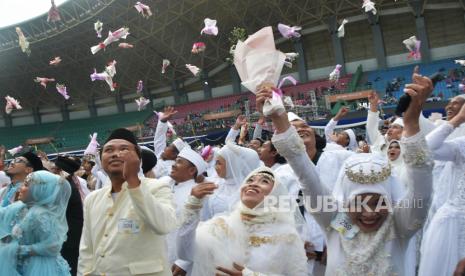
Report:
0,59,465,152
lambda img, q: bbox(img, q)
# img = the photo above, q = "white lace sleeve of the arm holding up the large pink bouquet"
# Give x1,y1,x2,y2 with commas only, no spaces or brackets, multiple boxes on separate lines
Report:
271,126,336,229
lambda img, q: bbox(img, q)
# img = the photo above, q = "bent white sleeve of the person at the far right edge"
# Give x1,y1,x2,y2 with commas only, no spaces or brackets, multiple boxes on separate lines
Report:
426,123,460,162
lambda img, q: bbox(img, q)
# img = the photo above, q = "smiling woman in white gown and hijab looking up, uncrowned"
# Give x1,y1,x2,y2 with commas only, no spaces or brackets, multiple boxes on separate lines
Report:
178,167,307,276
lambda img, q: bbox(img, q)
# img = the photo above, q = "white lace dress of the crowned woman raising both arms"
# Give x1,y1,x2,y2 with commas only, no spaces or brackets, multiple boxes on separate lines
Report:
272,127,432,276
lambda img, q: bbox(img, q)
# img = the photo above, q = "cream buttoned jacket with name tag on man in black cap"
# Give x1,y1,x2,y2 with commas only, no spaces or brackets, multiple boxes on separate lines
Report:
78,178,177,276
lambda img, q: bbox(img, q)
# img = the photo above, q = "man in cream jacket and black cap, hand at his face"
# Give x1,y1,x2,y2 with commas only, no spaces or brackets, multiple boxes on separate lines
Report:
78,129,176,276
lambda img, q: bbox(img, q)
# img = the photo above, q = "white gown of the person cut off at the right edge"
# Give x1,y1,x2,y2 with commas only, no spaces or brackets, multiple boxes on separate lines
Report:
419,124,465,276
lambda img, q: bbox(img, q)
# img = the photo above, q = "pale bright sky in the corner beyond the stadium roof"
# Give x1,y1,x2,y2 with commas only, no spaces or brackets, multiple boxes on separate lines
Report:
0,0,69,28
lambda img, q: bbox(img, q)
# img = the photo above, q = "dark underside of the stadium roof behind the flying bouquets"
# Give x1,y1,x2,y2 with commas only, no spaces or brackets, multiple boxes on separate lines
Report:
0,0,456,109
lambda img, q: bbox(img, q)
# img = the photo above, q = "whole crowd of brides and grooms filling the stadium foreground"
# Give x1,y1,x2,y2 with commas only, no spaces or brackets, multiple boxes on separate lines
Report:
0,68,465,276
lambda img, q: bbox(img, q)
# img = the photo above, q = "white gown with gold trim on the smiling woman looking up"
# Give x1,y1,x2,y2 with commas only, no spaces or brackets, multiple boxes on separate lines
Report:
178,196,308,276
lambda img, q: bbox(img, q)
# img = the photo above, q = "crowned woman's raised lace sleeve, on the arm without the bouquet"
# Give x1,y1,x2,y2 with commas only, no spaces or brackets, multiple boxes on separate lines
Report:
394,132,434,238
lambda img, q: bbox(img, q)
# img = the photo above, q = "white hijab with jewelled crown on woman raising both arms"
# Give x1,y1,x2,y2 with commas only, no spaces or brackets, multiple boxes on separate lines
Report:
333,153,403,275
